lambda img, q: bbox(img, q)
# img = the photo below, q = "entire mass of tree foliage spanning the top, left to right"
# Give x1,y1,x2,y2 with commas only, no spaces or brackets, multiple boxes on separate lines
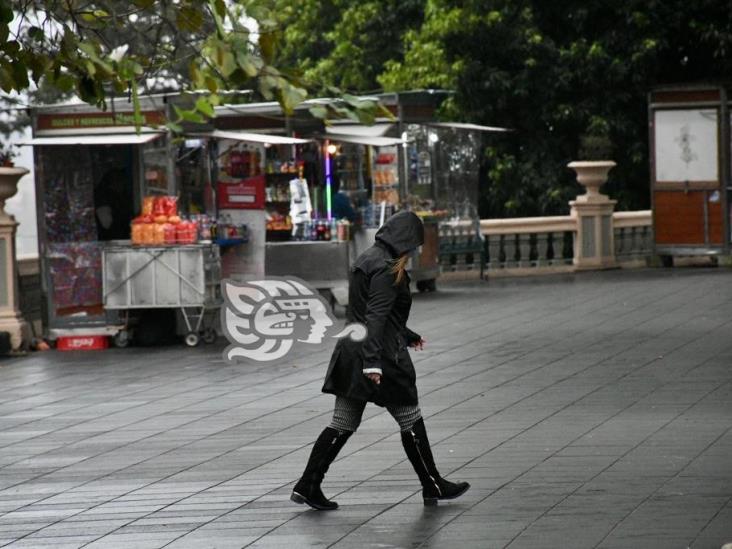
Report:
5,0,732,216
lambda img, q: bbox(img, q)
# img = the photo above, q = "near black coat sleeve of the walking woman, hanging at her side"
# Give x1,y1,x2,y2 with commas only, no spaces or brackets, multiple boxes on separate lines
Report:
363,268,397,370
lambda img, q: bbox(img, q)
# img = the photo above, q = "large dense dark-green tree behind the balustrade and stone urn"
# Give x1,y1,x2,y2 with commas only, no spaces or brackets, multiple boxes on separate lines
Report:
379,0,732,216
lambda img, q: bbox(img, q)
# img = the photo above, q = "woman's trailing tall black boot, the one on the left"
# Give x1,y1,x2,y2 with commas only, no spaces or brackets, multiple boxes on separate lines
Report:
290,427,353,511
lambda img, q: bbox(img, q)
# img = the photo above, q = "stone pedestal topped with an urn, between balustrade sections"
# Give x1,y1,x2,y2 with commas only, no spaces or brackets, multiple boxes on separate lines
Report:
567,160,617,270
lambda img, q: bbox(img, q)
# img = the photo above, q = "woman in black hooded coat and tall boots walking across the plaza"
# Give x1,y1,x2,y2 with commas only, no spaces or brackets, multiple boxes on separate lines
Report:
291,211,470,510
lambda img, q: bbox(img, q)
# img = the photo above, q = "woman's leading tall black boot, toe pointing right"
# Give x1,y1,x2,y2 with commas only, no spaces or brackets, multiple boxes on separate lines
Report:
402,418,470,505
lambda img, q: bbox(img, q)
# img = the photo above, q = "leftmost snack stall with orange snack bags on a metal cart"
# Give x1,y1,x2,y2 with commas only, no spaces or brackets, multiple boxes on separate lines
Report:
23,95,245,348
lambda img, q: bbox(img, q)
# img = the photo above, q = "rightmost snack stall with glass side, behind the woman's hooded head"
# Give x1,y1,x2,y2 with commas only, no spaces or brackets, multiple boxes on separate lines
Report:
326,120,507,291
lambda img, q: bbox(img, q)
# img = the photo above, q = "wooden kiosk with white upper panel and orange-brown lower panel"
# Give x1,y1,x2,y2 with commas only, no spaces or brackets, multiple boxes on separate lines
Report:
648,86,732,266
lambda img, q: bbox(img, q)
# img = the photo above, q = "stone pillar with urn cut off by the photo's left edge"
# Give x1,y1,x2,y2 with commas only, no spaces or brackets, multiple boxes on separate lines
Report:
0,167,30,350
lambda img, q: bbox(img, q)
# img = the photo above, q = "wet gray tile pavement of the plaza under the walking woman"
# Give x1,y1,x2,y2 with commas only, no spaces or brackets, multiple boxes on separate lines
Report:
0,269,732,549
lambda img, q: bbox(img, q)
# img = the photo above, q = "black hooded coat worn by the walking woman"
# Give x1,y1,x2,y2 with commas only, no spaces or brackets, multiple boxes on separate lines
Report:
323,211,424,406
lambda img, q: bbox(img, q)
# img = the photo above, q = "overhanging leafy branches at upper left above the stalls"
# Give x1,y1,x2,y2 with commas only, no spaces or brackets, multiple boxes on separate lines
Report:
0,0,386,135
